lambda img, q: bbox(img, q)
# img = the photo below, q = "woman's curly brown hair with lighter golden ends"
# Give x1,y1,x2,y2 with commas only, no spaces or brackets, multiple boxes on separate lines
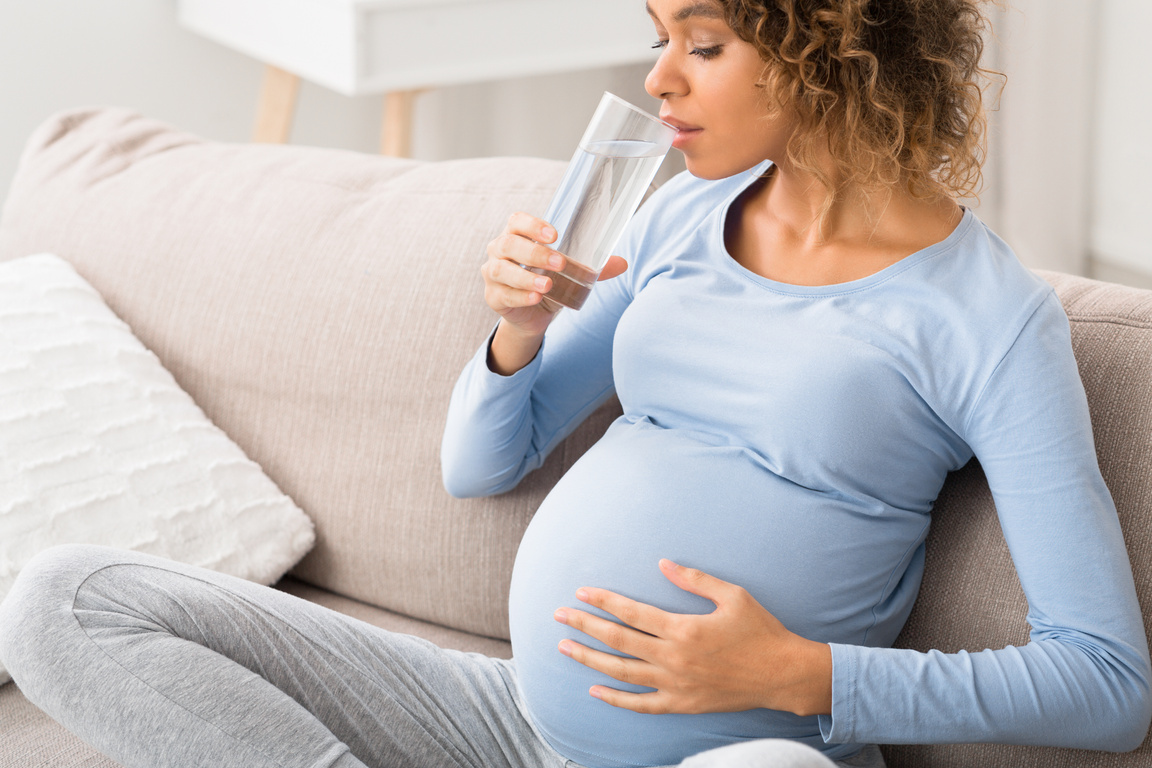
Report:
718,0,998,211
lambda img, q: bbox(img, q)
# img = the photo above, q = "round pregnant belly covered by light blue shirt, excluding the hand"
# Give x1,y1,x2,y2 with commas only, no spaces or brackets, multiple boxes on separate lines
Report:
509,419,924,768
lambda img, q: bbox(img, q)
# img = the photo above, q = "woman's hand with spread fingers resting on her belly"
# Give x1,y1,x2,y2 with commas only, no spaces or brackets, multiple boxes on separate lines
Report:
555,560,832,715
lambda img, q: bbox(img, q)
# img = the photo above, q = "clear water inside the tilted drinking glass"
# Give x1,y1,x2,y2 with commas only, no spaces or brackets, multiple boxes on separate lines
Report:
534,140,667,310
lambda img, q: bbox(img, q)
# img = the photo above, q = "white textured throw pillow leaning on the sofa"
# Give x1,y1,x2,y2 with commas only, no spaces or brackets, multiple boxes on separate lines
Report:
0,254,314,684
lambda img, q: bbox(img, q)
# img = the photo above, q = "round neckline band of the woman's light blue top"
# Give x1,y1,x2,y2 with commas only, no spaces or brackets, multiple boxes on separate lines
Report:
712,160,976,297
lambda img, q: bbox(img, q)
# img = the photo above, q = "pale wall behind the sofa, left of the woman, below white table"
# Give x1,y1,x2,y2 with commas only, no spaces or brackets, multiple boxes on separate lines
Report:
0,0,683,213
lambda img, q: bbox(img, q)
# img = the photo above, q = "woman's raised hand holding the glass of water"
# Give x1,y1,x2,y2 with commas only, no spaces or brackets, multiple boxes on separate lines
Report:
480,213,628,375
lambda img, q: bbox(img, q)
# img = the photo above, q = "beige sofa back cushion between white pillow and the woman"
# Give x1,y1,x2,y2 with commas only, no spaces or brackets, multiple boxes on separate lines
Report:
0,109,611,638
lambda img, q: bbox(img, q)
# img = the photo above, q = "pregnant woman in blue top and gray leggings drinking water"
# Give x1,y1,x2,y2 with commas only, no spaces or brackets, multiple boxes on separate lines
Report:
0,0,1152,768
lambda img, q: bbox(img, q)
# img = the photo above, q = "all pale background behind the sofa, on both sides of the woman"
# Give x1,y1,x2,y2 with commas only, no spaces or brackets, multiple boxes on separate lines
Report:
0,0,1152,283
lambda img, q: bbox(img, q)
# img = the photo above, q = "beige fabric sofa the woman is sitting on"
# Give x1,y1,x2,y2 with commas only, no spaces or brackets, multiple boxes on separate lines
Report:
0,109,1152,768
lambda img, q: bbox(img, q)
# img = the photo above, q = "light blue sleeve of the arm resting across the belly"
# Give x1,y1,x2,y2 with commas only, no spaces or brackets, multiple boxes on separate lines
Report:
820,295,1152,751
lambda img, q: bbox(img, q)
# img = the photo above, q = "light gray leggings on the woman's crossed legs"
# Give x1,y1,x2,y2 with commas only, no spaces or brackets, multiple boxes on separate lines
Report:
0,546,884,768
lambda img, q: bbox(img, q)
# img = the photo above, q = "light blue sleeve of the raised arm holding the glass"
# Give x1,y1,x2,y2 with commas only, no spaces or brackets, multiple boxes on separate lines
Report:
440,261,630,497
